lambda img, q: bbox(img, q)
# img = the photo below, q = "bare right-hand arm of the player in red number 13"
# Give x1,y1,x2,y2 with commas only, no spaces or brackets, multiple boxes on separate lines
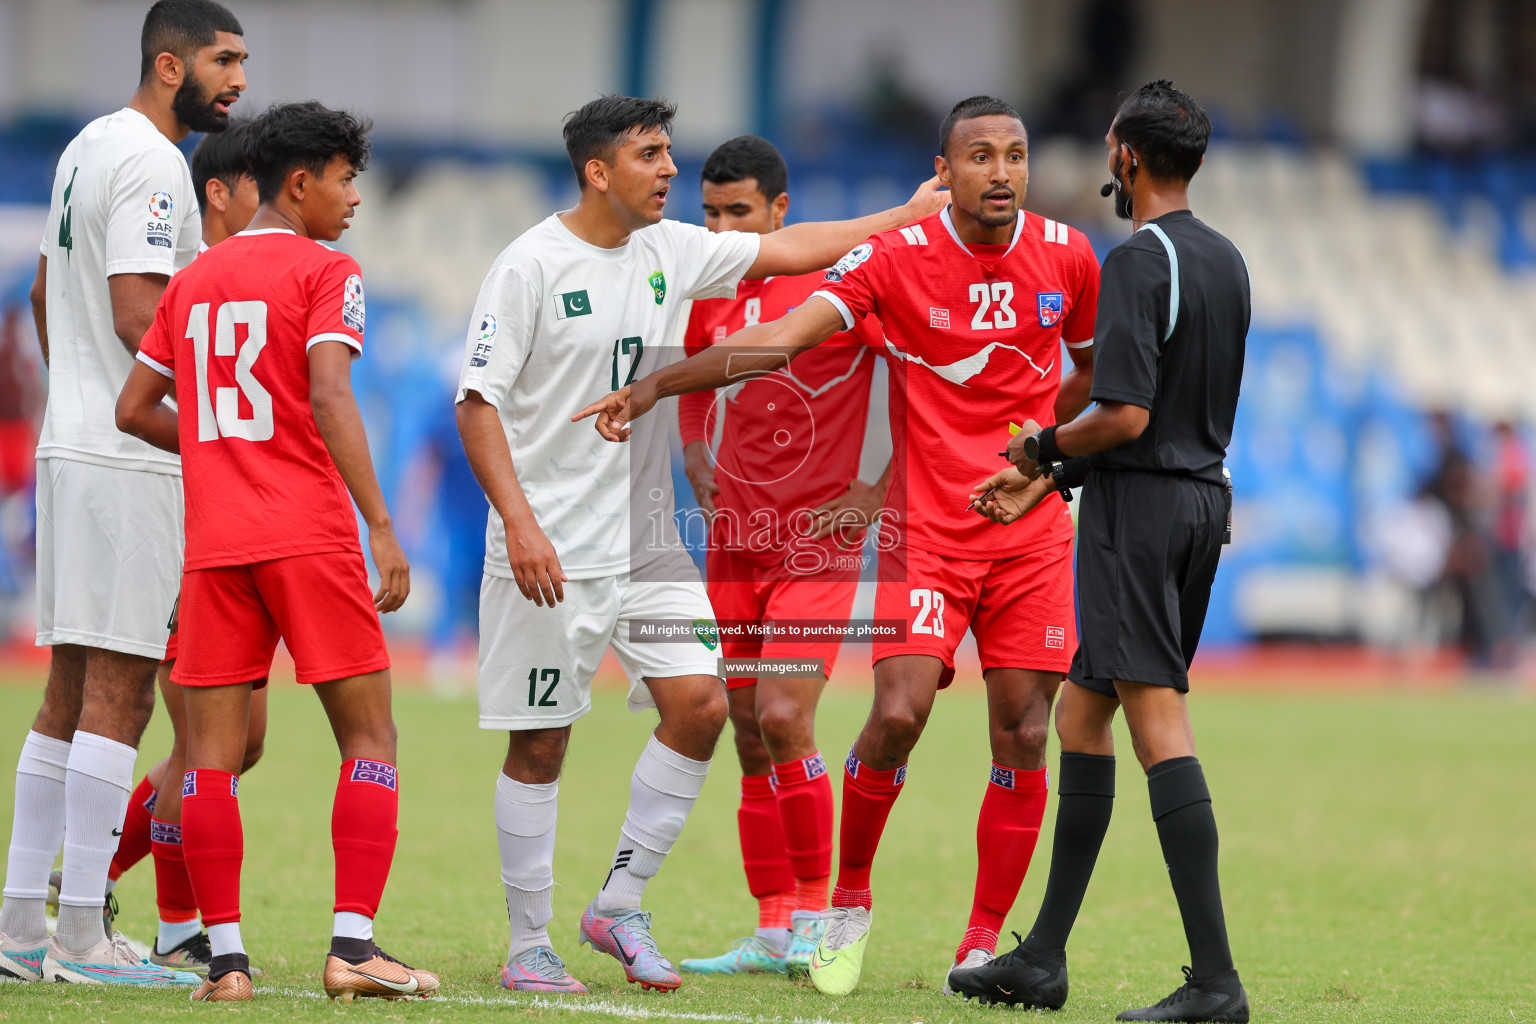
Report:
308,341,410,613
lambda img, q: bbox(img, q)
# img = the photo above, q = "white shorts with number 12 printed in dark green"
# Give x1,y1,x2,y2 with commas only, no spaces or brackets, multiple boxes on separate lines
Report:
479,576,723,731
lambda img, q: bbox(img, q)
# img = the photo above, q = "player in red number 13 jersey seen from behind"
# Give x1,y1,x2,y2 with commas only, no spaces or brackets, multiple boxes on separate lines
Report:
117,103,438,1001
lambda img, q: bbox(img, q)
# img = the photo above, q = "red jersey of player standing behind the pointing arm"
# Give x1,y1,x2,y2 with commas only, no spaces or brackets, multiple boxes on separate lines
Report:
677,273,880,573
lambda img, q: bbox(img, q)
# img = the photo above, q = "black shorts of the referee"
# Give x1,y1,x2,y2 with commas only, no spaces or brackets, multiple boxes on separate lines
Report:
1068,470,1226,697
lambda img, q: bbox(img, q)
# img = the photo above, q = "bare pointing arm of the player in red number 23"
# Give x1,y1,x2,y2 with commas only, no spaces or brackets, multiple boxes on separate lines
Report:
571,294,848,441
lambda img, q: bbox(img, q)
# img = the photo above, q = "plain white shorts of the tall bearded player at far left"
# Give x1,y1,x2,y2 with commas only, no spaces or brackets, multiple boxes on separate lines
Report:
37,459,181,659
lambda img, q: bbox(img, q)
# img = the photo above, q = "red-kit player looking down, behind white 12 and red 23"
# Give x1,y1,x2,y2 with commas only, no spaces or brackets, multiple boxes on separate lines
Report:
677,135,889,973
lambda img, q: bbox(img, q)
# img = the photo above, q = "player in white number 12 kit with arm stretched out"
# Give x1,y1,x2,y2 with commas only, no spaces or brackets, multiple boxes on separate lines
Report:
458,95,943,992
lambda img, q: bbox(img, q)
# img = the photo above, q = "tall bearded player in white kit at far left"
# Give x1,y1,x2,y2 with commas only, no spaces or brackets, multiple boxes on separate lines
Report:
0,0,246,986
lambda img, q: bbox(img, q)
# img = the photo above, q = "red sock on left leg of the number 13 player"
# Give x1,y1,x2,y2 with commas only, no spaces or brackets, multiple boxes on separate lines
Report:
181,768,246,924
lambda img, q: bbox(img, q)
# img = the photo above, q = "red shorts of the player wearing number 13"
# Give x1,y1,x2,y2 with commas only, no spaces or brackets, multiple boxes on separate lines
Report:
170,551,389,686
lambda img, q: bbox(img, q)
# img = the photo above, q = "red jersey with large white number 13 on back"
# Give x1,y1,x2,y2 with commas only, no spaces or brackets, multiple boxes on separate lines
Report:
138,229,364,570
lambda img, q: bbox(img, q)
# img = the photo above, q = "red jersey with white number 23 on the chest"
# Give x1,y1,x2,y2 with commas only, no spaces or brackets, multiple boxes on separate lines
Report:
816,207,1098,559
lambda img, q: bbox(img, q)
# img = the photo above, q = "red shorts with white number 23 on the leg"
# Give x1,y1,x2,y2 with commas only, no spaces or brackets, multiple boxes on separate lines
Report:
874,540,1077,686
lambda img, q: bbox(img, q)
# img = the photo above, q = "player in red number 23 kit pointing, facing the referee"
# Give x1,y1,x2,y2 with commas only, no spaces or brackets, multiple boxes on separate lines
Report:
578,97,1098,995
